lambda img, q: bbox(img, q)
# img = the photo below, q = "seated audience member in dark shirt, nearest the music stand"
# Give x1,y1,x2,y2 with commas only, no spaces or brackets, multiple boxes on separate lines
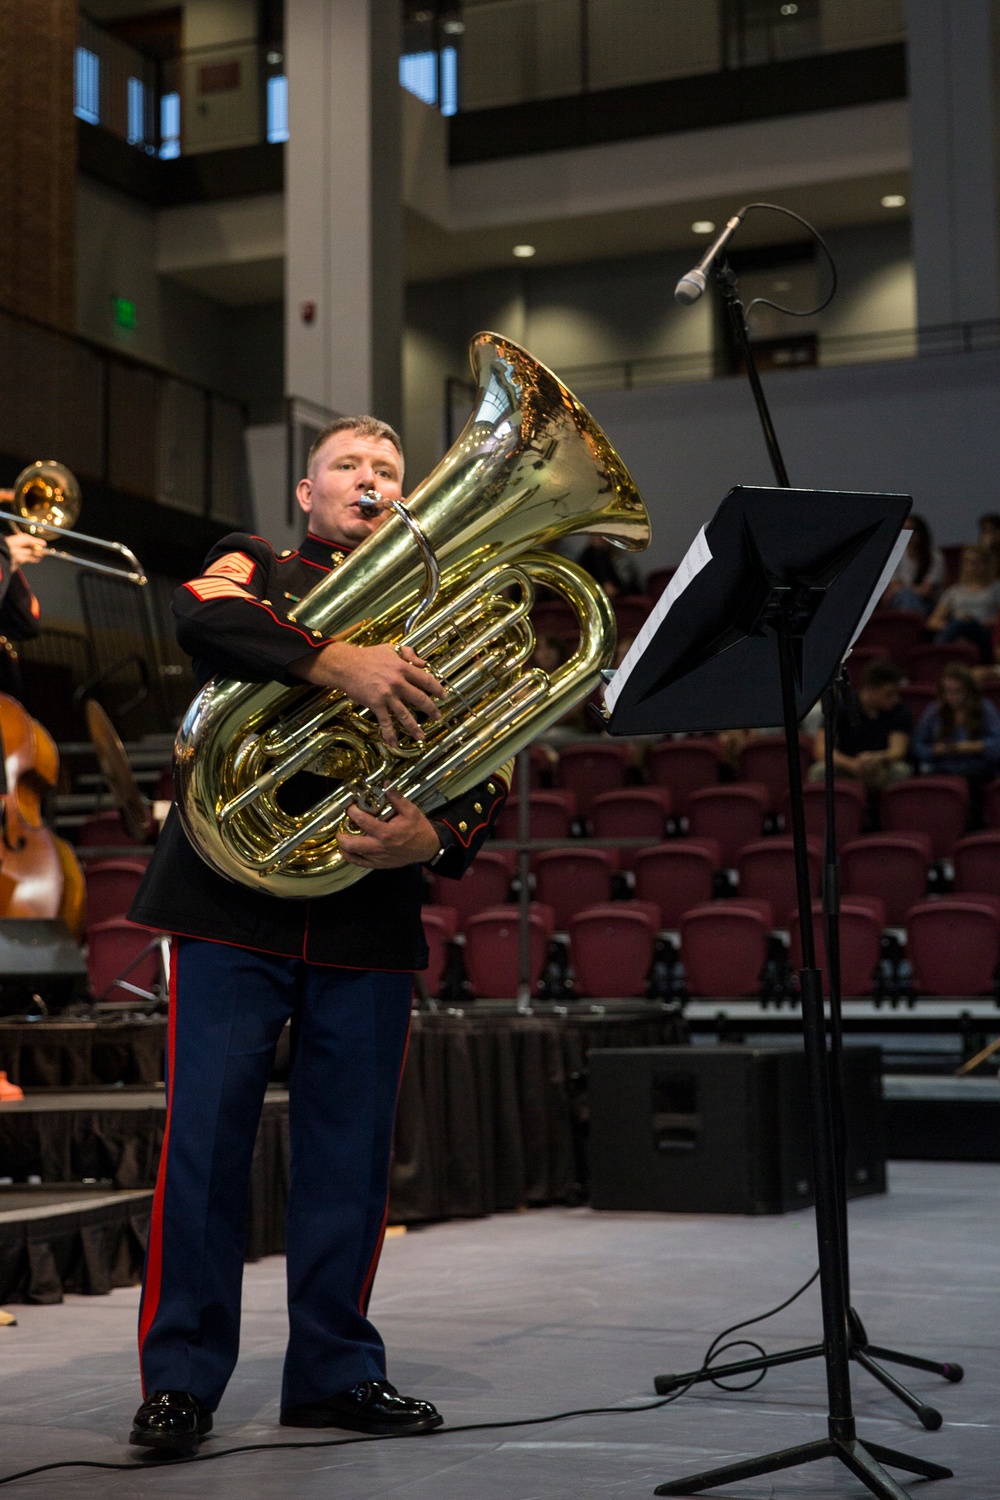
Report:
810,662,913,792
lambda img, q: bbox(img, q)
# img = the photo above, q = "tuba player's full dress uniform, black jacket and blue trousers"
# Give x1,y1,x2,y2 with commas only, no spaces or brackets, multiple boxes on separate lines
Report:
129,534,507,1446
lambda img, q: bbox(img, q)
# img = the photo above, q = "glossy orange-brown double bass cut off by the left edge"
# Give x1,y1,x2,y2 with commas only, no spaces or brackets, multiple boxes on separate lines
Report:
0,693,85,941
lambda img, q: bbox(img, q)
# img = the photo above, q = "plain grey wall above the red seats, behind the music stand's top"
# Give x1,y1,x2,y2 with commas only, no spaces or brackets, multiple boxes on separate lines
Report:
586,353,1000,569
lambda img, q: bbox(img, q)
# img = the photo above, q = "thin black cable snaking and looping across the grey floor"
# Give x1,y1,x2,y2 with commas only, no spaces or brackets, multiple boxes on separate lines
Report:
0,1268,819,1485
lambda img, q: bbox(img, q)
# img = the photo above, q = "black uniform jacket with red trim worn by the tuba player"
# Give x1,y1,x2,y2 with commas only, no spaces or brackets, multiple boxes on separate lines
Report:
129,533,508,971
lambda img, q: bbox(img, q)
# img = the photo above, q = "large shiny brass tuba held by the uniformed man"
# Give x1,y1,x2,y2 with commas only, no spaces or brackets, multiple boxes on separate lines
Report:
175,333,649,897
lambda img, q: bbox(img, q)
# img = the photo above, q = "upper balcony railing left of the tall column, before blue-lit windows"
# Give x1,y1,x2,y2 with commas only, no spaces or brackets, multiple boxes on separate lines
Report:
73,14,288,161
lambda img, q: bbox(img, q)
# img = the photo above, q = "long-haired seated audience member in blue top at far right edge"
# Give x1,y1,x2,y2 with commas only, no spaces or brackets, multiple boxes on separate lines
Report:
913,662,1000,822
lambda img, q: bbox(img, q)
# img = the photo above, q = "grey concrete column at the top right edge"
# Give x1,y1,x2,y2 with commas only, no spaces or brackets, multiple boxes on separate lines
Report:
907,0,1000,327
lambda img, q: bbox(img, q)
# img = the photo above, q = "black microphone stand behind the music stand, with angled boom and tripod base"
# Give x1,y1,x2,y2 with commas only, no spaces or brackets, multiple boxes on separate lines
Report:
654,257,964,1428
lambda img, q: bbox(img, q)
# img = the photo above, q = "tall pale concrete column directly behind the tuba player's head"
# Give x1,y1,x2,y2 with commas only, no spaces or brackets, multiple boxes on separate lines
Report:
285,0,403,425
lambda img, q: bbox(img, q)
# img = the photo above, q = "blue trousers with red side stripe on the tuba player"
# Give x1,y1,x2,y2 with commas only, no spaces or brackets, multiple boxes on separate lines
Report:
139,938,412,1410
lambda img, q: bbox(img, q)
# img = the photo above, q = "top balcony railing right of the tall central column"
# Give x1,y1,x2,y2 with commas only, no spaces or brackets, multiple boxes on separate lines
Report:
400,0,906,114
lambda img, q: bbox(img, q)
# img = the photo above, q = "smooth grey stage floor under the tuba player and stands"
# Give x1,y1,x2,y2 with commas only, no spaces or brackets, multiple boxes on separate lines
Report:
0,1163,1000,1500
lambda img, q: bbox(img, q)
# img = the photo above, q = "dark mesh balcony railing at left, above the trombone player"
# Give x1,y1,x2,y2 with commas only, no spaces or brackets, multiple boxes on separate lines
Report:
0,309,249,525
